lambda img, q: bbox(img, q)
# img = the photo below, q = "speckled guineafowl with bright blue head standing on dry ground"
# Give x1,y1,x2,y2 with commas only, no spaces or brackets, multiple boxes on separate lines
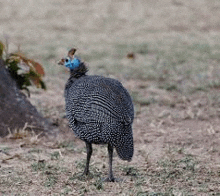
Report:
58,48,134,182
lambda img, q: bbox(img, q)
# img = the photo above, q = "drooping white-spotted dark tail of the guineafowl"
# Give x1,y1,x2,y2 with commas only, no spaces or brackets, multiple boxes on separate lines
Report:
115,124,134,161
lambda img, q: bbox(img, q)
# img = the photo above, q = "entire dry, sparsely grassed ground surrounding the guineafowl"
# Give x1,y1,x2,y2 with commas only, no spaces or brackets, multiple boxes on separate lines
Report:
0,0,220,196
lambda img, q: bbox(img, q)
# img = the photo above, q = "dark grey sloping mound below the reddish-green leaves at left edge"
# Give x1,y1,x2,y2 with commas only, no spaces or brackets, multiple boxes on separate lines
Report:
0,59,53,137
